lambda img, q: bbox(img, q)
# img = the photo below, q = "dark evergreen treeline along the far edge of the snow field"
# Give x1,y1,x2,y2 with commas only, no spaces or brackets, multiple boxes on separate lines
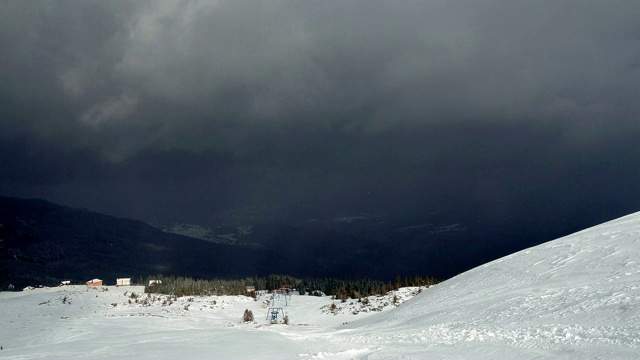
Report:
139,275,438,300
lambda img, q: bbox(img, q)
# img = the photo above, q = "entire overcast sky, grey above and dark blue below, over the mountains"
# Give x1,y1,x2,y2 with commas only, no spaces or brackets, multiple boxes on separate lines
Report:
0,0,640,233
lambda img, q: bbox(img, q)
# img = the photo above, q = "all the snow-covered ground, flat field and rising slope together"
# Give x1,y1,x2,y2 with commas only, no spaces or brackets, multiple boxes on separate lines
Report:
0,213,640,359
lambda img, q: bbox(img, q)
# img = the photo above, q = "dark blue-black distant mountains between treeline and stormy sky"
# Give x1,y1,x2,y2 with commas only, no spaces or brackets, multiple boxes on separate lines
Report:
0,197,544,289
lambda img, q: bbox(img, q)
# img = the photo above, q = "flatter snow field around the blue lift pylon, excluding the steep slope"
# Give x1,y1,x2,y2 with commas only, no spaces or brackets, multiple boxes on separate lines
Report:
0,286,418,359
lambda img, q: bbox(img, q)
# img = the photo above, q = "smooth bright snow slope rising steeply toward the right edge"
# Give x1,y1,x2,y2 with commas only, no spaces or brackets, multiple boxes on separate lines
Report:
338,213,640,359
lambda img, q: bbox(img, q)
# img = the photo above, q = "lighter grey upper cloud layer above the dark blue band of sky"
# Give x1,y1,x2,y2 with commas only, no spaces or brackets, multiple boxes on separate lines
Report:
0,1,640,159
